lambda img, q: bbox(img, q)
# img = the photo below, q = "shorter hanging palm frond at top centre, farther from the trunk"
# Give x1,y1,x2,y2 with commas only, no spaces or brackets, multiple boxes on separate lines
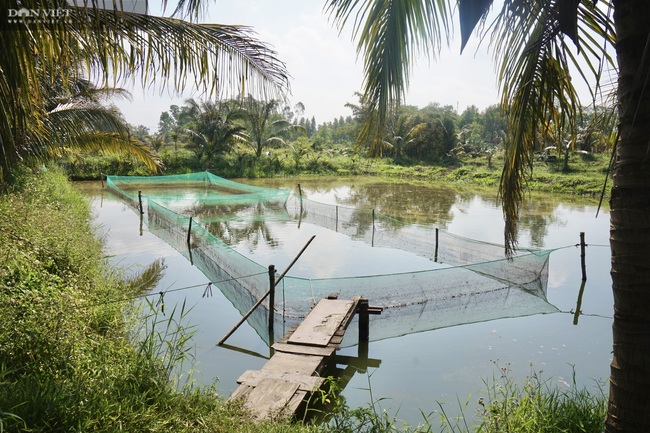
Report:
325,0,451,154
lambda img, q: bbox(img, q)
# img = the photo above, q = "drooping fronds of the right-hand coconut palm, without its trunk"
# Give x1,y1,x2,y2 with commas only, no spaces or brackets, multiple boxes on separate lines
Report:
326,0,615,254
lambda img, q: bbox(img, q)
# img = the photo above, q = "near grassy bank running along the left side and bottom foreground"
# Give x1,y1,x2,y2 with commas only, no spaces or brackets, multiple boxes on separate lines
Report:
0,167,605,433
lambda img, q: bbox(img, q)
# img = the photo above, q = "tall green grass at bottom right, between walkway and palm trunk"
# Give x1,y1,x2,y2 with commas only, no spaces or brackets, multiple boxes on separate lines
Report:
323,366,607,433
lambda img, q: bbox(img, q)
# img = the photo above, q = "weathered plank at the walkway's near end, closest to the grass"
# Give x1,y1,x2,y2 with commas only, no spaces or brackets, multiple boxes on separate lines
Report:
244,378,298,419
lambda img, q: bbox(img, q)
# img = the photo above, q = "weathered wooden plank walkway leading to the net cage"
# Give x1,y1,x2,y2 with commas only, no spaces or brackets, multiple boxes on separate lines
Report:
229,298,367,421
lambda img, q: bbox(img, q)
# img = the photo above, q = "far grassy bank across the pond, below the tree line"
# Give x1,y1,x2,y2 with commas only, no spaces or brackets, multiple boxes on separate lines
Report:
64,149,610,199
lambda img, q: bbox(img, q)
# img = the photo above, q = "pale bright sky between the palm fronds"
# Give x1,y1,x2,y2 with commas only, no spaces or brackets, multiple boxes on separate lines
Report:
114,0,498,133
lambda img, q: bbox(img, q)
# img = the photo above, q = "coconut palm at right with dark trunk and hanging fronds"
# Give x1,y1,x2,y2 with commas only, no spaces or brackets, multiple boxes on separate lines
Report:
326,0,650,432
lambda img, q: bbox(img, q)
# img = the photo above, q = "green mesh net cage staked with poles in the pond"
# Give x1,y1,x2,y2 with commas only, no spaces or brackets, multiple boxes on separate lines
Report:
107,172,558,345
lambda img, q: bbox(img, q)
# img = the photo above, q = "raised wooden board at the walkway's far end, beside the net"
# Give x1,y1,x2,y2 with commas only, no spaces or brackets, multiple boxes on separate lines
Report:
289,299,355,346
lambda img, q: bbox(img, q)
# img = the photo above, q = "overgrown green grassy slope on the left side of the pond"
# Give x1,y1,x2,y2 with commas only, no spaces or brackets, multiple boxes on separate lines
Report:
0,168,316,432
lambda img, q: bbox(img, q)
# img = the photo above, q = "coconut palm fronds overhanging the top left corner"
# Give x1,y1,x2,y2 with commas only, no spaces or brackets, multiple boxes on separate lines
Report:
0,0,287,182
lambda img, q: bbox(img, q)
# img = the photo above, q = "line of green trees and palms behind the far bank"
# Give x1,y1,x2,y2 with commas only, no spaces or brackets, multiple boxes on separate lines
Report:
134,94,616,169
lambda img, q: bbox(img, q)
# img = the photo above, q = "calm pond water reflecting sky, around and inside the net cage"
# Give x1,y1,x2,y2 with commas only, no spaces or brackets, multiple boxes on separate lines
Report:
79,178,613,424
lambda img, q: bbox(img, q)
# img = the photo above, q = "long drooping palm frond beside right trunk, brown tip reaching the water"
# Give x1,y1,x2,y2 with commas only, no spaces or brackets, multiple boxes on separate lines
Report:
492,0,614,255
